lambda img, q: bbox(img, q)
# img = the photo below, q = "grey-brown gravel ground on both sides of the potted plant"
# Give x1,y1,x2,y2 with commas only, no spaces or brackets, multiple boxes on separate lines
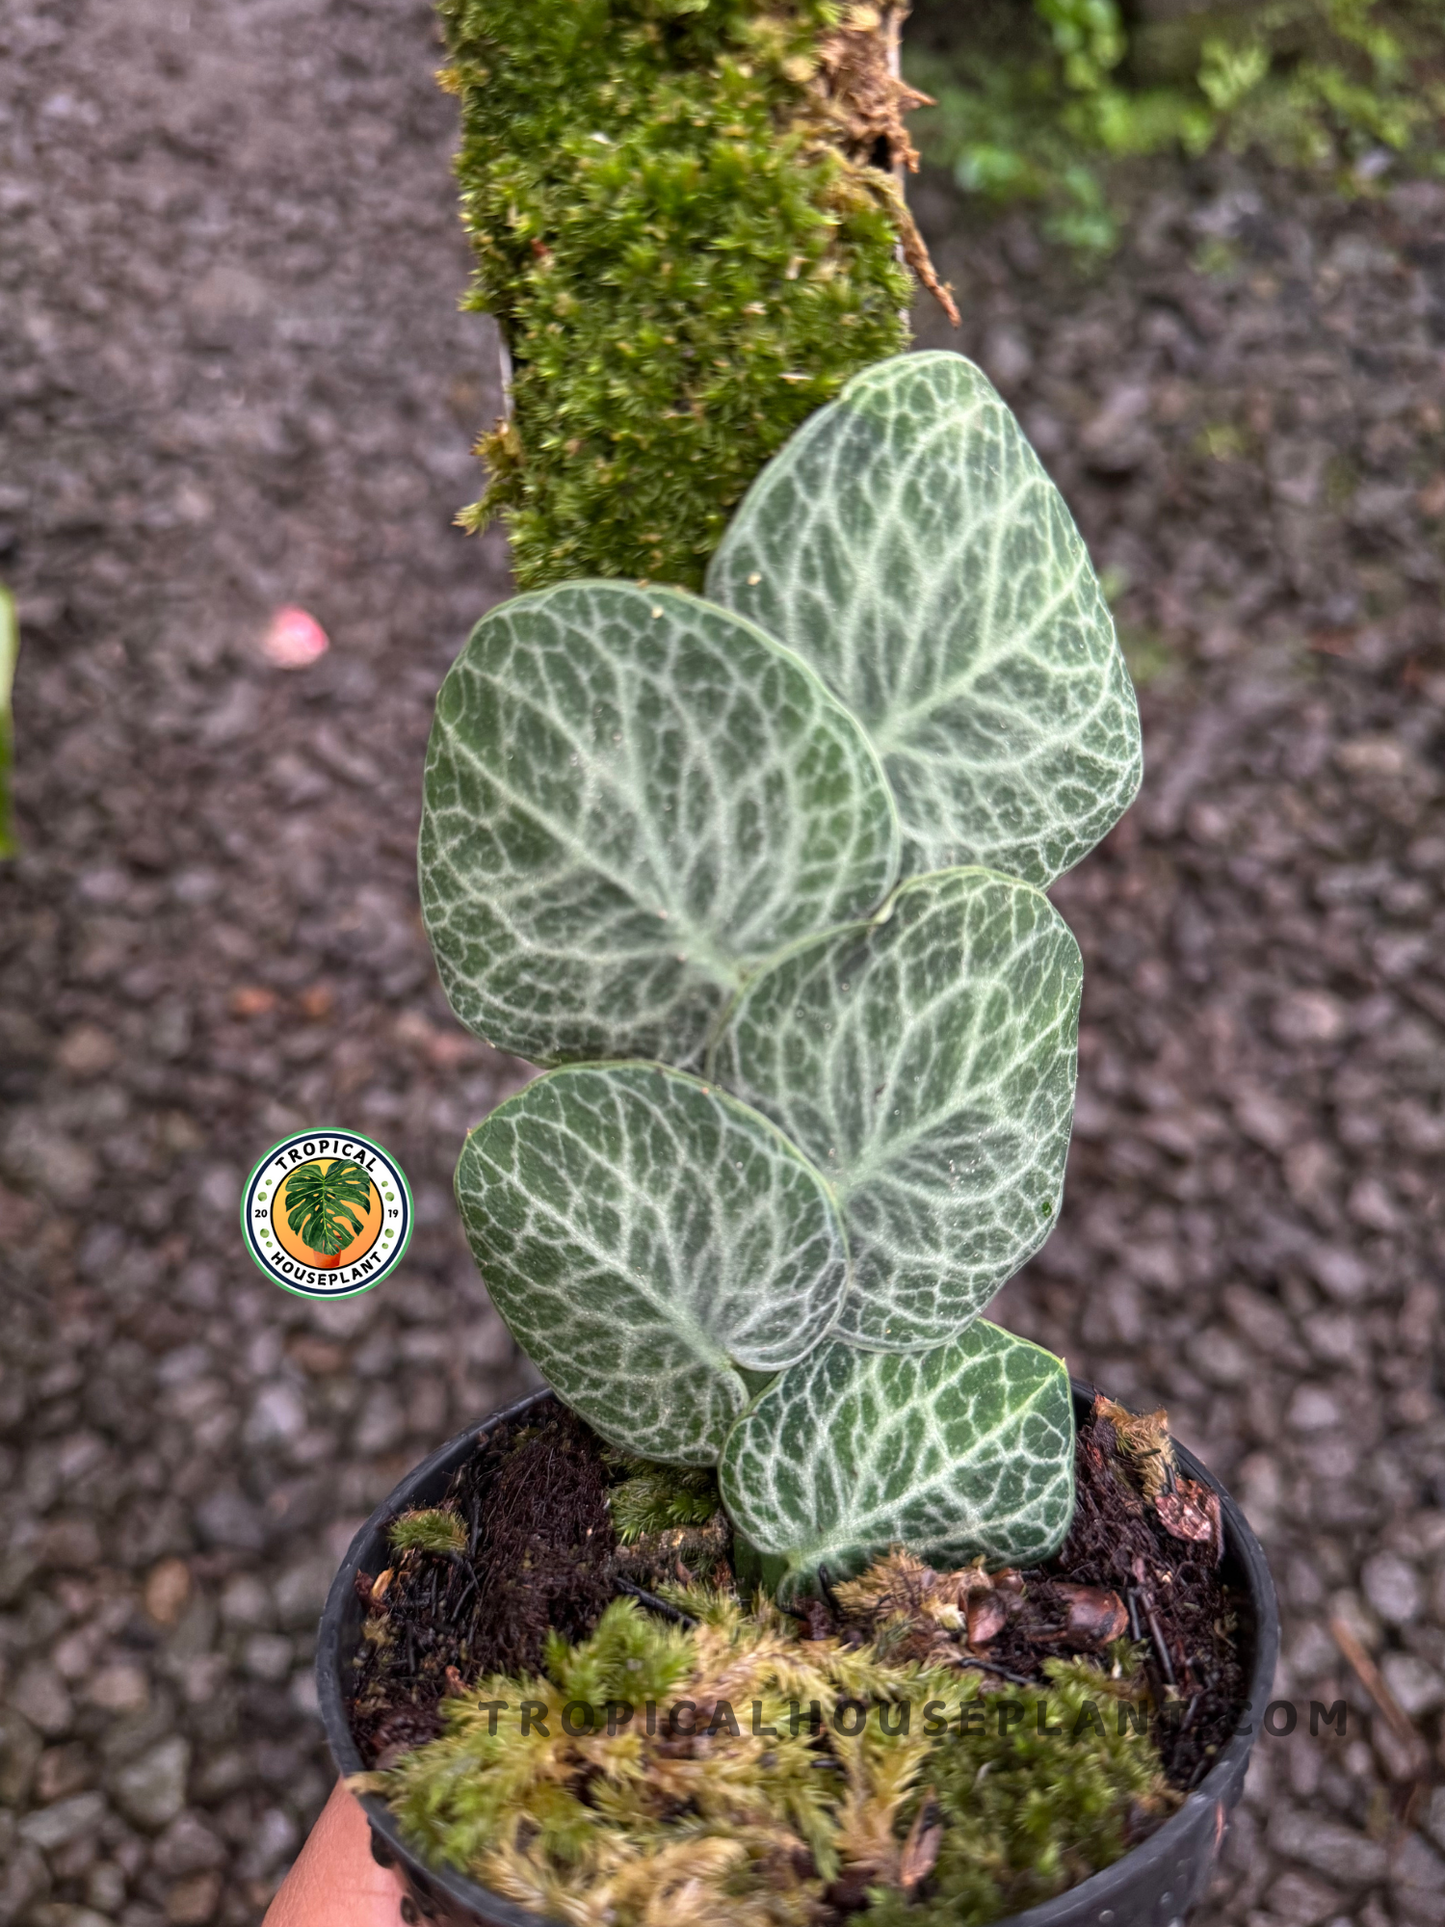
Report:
0,0,1445,1927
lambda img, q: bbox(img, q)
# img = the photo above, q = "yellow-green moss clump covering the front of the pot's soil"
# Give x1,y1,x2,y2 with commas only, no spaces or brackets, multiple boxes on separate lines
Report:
358,1586,1177,1927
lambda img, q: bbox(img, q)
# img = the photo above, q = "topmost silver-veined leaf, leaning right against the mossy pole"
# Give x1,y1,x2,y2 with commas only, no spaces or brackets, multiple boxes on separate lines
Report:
707,353,1143,884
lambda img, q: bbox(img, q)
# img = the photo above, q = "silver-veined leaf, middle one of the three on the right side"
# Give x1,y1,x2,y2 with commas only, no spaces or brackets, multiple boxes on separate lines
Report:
713,869,1083,1351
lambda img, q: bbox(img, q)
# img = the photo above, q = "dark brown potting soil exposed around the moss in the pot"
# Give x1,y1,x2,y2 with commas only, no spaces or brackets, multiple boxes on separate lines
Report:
351,1403,1245,1790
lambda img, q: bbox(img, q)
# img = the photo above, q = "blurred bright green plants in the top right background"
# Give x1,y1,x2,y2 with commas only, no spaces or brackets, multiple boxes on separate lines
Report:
904,0,1445,254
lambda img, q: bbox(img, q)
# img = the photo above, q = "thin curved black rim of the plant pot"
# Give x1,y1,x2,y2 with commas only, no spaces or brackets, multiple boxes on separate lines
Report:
316,1378,1279,1927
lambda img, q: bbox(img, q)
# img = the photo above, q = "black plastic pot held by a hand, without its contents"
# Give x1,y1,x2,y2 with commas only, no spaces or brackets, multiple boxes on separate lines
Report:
316,1380,1279,1927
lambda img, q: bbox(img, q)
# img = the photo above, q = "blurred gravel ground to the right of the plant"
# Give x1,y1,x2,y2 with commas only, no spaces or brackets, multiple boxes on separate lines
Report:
921,170,1445,1927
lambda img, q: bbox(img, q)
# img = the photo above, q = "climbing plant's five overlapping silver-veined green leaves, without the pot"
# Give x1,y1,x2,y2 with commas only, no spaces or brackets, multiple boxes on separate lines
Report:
420,355,1141,1592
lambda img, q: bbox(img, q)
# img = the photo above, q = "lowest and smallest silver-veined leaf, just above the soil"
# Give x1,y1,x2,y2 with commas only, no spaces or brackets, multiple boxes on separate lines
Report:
719,1318,1073,1592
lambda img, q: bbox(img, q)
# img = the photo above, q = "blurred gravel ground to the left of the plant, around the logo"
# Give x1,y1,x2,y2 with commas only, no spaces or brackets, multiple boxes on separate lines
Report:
0,0,535,1927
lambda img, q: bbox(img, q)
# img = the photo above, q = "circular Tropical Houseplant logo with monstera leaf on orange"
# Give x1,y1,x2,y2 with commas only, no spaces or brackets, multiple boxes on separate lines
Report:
241,1131,412,1299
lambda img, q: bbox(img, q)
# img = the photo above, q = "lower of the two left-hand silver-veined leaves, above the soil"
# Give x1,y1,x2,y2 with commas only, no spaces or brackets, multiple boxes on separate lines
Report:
457,1064,848,1465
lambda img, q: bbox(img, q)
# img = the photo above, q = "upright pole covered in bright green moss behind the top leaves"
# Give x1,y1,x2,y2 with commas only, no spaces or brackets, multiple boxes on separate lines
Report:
441,0,931,588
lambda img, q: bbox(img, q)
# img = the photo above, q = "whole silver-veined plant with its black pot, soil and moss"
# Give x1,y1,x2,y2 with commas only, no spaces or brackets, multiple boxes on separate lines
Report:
318,355,1277,1927
